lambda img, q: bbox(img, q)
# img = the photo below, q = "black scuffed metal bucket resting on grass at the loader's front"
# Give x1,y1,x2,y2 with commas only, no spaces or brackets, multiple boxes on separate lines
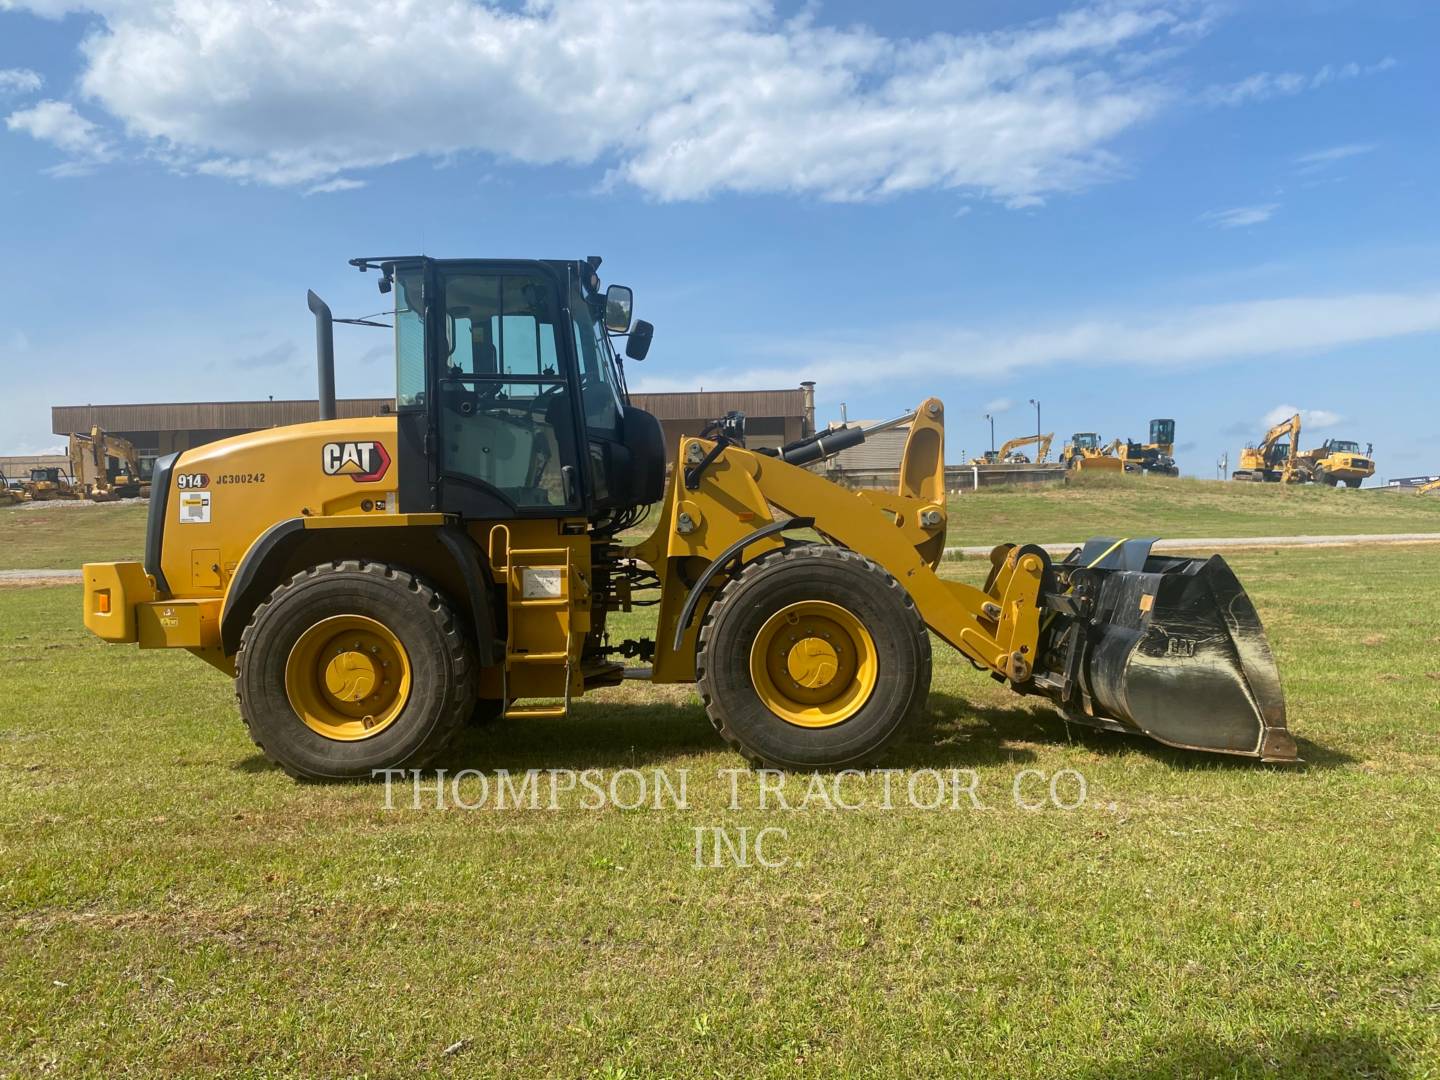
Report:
1071,543,1299,762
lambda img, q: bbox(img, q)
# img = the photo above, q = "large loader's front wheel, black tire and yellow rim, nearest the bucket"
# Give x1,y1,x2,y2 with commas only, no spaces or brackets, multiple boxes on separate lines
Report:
696,544,930,769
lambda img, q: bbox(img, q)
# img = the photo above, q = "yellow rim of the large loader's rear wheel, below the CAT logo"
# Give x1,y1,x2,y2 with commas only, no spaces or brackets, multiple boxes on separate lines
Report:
285,615,410,743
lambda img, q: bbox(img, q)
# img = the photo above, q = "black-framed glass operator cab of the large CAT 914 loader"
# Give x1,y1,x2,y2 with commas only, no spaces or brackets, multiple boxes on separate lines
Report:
351,256,665,520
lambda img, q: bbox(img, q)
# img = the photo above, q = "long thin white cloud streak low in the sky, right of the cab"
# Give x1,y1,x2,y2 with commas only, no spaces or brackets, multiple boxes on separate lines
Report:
671,288,1440,392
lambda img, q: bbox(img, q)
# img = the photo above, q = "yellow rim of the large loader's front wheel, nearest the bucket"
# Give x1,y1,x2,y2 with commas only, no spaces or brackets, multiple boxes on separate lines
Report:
750,600,878,727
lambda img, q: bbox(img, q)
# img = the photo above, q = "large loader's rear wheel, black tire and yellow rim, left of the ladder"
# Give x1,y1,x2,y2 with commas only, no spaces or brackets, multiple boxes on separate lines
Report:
235,560,477,780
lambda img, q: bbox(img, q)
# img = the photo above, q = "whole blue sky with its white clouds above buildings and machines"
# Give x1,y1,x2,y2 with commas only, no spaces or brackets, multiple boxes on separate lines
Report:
0,0,1440,477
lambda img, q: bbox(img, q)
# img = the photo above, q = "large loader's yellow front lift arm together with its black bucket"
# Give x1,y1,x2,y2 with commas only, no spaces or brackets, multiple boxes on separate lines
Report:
628,399,1296,760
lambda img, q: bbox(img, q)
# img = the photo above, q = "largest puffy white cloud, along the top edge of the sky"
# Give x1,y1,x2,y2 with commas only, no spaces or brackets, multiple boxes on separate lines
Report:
6,0,1208,206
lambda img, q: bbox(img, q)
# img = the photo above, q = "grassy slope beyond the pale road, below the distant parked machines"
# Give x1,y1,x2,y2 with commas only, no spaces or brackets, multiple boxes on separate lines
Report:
0,477,1440,570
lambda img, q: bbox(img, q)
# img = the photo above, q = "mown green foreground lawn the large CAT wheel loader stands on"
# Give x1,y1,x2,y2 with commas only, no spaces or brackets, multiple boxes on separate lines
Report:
0,544,1440,1080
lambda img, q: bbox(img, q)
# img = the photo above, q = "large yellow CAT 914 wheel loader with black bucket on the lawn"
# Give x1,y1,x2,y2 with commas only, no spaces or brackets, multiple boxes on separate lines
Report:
75,256,1296,778
